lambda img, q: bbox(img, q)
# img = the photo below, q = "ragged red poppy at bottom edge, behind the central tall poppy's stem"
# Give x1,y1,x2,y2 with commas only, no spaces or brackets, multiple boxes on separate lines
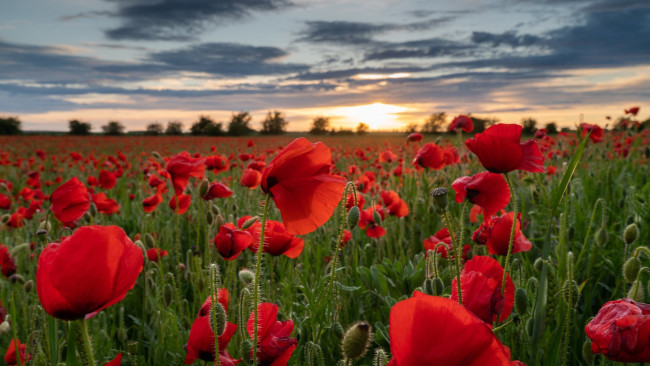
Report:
246,302,298,366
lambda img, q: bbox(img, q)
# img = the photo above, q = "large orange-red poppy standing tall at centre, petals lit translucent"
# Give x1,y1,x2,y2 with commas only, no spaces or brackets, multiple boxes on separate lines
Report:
262,138,346,235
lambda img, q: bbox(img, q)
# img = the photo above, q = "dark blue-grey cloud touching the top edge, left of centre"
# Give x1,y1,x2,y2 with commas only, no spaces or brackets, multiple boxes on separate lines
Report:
106,0,291,41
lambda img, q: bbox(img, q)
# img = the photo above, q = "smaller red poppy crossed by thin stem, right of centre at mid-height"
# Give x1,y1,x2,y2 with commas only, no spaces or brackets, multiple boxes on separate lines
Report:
472,212,533,255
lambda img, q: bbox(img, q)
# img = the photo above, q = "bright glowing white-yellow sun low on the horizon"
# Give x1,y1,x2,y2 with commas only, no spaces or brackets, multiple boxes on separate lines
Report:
331,103,409,130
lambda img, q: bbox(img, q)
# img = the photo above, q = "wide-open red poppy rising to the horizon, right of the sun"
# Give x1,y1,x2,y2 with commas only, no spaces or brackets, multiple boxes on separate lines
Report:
465,123,544,173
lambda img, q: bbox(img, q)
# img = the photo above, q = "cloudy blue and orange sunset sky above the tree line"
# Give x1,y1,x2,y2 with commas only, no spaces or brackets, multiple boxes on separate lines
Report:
0,0,650,131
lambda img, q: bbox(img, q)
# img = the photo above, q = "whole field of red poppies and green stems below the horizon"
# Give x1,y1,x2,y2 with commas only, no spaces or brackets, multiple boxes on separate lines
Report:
0,116,650,366
